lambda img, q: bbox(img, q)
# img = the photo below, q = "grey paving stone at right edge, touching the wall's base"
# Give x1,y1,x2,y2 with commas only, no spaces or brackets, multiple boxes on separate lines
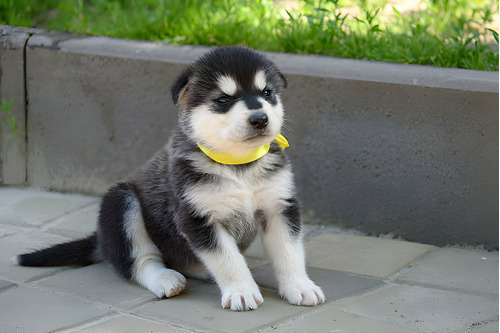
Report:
398,248,498,295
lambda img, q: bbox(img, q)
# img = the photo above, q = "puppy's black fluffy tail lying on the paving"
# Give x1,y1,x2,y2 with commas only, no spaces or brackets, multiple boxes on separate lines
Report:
16,234,99,267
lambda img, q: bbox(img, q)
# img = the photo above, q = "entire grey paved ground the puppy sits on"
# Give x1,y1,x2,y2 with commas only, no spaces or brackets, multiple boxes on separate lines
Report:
0,186,499,333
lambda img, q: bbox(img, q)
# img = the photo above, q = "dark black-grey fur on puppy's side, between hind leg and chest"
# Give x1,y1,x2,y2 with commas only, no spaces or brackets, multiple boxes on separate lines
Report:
127,132,223,268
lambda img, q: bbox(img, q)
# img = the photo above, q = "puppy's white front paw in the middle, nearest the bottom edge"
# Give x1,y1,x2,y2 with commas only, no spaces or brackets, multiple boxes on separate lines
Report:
222,282,264,311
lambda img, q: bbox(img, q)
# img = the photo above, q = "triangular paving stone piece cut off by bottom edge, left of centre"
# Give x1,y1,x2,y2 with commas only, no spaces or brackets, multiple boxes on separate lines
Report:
74,315,185,333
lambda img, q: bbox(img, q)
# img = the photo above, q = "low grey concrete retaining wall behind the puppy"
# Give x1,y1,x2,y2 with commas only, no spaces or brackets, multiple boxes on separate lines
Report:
0,26,498,248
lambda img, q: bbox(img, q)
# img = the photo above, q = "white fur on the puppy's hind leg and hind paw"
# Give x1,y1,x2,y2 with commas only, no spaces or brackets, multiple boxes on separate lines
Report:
124,197,186,298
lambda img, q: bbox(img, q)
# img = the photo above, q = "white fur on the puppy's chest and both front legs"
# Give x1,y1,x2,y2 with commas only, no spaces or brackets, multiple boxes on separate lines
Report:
186,155,325,310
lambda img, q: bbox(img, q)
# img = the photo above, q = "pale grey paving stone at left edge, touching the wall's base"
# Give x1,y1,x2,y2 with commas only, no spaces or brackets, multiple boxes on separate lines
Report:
0,187,98,226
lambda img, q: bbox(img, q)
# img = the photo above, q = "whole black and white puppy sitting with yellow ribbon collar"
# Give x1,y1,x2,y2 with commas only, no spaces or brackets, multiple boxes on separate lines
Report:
17,46,325,310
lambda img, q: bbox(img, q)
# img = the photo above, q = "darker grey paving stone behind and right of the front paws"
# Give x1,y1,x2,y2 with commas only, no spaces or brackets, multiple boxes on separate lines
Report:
252,264,384,302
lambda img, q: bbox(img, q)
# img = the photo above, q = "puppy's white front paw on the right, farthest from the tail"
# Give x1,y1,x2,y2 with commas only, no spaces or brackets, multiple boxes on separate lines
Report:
279,279,325,306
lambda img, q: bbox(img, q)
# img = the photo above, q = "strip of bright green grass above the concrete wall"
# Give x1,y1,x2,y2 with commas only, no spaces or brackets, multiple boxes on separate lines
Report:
0,0,498,71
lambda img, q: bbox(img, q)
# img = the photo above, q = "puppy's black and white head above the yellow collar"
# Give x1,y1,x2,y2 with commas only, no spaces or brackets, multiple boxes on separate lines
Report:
172,46,286,156
